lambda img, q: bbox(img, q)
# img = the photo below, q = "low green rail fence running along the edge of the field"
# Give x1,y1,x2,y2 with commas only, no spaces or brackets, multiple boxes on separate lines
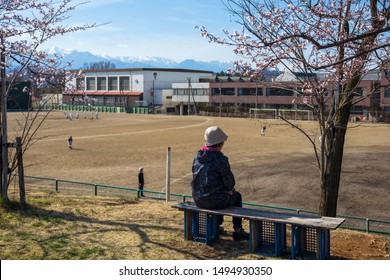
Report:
16,176,390,234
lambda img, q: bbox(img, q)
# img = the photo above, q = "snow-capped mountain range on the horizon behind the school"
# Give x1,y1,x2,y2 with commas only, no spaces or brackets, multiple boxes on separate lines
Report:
47,49,233,72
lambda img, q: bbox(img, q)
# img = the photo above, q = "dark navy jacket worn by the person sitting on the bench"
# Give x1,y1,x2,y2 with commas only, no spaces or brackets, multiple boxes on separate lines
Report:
191,148,236,209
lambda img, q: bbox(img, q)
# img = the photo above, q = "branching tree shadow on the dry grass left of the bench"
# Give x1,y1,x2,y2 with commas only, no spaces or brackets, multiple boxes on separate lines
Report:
5,201,244,260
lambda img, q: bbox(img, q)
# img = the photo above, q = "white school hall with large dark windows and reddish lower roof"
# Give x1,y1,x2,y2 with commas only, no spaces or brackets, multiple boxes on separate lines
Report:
62,68,213,113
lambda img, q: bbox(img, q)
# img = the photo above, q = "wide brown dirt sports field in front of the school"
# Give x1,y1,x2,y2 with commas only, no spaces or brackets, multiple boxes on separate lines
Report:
8,109,390,220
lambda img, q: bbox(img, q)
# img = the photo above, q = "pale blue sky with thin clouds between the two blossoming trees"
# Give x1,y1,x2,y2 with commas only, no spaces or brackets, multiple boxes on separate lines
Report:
45,0,240,62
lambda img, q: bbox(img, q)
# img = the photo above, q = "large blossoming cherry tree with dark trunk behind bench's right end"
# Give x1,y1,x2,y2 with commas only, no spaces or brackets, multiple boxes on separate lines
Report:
200,0,390,216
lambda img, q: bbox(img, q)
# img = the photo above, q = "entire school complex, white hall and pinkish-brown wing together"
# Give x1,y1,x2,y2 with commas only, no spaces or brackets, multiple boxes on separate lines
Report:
62,62,390,121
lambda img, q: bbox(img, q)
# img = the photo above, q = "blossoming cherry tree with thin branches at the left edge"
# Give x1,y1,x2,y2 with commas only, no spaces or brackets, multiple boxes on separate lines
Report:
0,0,97,206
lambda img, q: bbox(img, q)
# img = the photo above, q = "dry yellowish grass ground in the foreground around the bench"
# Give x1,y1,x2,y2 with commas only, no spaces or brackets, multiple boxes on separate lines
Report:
0,191,390,260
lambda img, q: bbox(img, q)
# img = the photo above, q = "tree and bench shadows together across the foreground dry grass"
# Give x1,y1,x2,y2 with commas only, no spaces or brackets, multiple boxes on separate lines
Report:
3,200,345,260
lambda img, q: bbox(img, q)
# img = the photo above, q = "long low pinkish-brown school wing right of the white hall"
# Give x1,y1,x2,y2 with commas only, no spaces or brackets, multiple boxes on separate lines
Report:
172,62,390,121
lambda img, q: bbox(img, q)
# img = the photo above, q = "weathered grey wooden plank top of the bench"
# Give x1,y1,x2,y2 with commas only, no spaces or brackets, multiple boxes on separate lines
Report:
172,201,345,229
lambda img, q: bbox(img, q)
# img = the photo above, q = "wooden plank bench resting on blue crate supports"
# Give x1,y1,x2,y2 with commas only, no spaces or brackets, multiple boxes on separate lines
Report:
172,202,345,259
